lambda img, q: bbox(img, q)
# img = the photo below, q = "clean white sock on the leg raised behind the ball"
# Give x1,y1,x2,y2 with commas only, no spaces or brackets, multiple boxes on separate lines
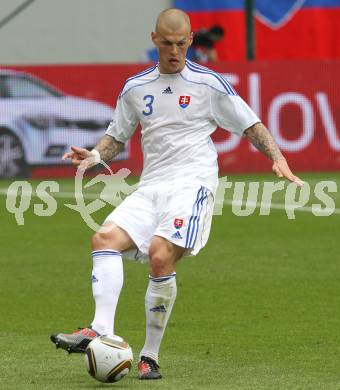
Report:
91,249,123,336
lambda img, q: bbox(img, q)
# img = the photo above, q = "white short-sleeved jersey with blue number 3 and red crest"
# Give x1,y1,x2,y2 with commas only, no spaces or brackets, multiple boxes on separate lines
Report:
106,60,260,192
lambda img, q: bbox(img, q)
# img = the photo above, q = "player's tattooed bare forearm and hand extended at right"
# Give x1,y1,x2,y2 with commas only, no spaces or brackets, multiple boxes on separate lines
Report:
244,122,303,186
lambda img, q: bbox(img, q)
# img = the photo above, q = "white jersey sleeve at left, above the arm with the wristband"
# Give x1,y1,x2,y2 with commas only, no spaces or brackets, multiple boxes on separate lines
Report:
106,94,138,143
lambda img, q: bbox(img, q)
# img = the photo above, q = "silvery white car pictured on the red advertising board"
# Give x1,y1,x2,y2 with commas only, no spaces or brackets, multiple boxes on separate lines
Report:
0,69,123,177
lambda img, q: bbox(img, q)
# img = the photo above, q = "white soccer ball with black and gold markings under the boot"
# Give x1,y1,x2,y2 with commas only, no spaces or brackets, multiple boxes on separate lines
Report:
85,336,133,383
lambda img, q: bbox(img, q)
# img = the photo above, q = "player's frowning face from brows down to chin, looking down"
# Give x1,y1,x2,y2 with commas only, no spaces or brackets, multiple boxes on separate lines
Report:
152,30,192,73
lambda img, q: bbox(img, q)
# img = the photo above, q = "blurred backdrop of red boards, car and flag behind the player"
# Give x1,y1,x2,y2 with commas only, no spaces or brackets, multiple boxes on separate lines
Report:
0,0,340,178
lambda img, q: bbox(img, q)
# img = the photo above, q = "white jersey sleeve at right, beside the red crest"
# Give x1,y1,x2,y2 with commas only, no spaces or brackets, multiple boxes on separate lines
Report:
211,91,261,135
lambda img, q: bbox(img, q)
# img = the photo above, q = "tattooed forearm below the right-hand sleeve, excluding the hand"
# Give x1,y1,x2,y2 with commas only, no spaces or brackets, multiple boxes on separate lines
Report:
244,122,284,161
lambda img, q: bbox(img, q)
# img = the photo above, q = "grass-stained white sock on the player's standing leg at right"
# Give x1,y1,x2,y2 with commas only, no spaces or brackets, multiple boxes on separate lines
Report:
140,272,177,362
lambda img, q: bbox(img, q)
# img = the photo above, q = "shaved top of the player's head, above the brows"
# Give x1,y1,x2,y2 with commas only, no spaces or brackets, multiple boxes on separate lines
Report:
155,8,191,33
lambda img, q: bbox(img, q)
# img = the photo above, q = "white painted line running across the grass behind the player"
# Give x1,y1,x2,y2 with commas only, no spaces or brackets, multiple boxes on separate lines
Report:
0,188,340,215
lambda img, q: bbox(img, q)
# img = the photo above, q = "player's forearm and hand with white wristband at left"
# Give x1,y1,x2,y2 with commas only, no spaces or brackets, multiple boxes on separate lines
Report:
63,135,124,169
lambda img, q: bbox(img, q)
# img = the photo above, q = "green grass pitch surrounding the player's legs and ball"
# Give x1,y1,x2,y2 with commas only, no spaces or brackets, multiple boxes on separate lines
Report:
0,173,340,390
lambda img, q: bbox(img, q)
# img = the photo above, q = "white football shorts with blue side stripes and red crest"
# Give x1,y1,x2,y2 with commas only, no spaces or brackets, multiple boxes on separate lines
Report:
105,184,214,260
